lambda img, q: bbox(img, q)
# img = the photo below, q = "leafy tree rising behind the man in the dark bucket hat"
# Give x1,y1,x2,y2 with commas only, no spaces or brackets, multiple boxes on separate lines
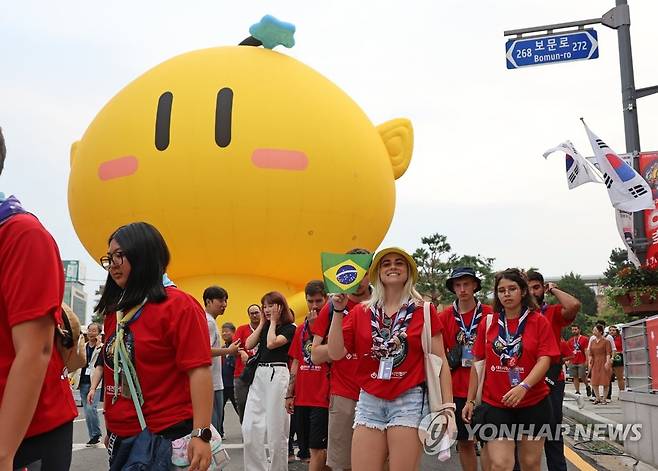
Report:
413,233,495,304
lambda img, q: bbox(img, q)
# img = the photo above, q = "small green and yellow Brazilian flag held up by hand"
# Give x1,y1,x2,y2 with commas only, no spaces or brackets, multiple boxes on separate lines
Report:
321,252,372,293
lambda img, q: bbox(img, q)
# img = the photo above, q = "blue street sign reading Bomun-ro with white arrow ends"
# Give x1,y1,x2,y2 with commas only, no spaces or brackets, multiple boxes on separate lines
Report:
505,29,599,69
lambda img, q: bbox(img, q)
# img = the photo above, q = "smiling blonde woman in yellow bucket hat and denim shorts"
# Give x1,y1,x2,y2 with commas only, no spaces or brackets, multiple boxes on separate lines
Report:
328,247,454,471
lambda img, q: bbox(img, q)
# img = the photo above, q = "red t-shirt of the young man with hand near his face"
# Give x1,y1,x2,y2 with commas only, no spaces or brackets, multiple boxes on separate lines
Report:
288,322,329,407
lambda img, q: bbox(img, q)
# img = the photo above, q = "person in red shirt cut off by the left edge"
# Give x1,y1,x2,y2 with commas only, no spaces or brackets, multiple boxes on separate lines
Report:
0,130,77,470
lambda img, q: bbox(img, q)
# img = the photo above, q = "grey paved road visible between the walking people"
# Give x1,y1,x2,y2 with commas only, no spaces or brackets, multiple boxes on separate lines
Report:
71,407,579,471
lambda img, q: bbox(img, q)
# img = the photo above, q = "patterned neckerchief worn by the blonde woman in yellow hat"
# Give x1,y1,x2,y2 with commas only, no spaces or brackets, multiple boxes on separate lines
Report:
370,298,416,359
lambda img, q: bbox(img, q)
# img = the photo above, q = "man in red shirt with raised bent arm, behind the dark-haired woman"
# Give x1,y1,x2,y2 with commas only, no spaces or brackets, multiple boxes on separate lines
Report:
527,270,580,471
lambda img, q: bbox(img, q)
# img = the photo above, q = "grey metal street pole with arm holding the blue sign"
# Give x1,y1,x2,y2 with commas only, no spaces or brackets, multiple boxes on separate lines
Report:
504,0,658,264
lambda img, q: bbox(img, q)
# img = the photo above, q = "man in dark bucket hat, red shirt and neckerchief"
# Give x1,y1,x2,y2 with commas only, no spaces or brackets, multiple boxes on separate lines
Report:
439,267,493,471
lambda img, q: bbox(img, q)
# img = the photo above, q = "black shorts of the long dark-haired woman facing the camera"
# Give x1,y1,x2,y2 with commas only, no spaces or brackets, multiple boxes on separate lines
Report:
474,396,559,442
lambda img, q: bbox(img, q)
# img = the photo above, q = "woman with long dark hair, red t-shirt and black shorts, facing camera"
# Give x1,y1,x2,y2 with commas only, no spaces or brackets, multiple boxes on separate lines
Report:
462,269,560,471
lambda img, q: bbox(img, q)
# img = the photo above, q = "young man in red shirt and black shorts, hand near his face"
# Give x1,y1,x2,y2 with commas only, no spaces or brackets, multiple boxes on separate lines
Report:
286,280,329,471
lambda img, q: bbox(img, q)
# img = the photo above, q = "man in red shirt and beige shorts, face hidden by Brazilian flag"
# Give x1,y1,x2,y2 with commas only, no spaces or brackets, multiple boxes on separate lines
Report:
311,249,370,470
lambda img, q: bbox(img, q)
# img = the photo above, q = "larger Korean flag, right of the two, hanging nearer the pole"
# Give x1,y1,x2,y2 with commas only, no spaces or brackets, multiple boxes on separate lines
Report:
583,120,655,213
